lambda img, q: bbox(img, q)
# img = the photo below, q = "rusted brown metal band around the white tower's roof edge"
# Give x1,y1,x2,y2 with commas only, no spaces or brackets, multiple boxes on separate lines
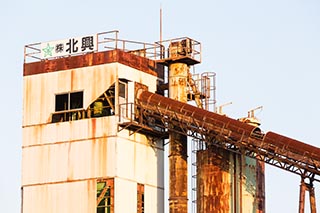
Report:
23,50,161,76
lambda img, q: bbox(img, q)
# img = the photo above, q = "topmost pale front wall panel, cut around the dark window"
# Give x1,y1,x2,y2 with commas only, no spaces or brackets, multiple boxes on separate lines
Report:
22,63,118,126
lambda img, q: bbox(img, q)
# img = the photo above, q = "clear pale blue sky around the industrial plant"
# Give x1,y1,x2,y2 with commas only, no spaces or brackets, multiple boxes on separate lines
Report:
0,0,320,213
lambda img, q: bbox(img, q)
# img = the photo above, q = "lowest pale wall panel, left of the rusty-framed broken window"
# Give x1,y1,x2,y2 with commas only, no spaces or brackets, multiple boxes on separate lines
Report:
22,180,96,213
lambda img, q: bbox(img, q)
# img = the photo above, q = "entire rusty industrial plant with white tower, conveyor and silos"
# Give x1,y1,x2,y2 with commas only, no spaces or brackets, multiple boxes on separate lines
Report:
21,31,320,213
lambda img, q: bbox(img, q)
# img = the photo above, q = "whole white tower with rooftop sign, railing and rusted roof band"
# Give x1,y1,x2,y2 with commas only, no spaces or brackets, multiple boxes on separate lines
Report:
22,31,164,213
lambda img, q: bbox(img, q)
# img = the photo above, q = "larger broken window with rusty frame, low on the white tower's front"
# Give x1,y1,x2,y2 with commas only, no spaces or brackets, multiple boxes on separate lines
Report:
97,179,114,213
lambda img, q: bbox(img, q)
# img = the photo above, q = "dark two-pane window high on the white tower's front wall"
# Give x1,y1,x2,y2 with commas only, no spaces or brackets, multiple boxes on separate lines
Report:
52,91,83,122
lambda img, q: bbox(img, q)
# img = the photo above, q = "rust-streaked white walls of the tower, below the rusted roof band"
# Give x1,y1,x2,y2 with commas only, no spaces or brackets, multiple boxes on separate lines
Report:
22,60,164,213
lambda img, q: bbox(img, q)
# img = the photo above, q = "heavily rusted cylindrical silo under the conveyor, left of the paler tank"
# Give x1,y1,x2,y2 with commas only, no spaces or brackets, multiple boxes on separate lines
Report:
197,148,232,213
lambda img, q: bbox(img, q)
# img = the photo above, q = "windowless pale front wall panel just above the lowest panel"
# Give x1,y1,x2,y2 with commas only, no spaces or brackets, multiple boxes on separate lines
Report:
22,133,117,185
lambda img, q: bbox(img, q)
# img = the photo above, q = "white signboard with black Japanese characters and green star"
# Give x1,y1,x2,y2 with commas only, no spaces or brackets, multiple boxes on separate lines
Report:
40,35,97,59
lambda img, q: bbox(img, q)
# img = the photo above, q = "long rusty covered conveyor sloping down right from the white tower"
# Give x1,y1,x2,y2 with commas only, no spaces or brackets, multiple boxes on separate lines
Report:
136,89,320,182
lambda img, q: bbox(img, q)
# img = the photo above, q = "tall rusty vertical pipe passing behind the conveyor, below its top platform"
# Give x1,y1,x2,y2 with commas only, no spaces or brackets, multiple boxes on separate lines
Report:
169,63,189,213
